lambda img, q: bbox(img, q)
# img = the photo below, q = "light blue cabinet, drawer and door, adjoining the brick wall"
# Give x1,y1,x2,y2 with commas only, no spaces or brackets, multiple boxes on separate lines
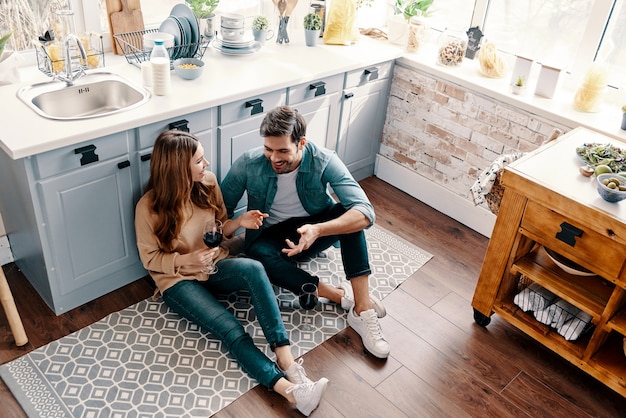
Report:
337,61,393,180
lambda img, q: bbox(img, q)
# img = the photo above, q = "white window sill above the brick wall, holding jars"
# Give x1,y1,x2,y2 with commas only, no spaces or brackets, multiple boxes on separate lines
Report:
397,45,626,142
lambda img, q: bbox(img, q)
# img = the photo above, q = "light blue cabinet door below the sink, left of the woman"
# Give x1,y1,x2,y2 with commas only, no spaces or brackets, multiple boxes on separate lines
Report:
38,156,141,314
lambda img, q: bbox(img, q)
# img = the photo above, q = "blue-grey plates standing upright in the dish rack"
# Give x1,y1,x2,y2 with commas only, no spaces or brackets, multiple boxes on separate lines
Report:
159,3,200,60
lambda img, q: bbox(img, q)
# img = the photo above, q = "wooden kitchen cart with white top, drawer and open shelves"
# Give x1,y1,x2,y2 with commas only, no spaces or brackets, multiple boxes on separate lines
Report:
472,128,626,397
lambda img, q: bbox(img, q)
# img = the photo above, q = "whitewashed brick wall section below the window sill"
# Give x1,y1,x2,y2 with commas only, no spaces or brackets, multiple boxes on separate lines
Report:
380,65,570,207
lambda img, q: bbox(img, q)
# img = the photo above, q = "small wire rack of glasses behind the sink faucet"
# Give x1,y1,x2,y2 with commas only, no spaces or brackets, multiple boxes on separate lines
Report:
35,34,104,77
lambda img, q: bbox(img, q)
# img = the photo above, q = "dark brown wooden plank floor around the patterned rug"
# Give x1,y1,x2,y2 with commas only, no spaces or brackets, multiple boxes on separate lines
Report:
0,177,626,418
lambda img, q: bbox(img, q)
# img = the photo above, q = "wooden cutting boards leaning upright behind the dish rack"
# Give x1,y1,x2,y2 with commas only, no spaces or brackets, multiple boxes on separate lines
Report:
106,0,145,55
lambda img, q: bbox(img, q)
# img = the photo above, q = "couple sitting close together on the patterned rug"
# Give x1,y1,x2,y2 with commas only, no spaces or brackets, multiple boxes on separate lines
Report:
135,106,389,416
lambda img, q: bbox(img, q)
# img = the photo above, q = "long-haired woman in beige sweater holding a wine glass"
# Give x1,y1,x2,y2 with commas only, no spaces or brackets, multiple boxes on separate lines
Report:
135,130,328,416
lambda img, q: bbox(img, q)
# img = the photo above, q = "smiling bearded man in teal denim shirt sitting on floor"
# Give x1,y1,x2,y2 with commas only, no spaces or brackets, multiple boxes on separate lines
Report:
221,106,390,358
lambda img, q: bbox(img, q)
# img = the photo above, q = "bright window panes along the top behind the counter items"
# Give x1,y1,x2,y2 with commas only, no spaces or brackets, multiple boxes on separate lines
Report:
0,0,626,88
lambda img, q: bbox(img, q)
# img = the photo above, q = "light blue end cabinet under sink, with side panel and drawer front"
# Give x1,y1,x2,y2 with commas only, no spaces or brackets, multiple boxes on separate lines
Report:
0,131,145,315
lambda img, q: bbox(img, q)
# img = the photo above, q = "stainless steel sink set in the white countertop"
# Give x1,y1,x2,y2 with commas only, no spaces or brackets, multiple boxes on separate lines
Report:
17,72,150,120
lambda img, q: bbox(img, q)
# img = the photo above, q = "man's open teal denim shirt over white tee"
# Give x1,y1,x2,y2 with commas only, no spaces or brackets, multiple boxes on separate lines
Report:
220,142,376,247
